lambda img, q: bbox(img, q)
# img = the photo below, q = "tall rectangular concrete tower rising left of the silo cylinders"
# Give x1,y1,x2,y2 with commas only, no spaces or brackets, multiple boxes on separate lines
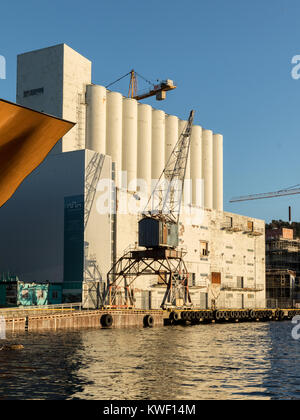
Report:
17,44,92,153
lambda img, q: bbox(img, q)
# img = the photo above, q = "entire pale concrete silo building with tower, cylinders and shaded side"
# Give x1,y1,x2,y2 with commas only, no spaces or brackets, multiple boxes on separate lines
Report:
0,44,265,308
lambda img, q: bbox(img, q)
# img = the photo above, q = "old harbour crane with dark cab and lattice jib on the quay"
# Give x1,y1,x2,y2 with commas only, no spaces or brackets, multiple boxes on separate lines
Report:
107,111,194,309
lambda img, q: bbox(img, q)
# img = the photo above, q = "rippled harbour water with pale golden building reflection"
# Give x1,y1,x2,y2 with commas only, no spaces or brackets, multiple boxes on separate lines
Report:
0,322,300,400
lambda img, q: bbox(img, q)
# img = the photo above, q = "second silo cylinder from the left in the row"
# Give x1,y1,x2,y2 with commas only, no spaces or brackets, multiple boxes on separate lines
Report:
106,92,123,186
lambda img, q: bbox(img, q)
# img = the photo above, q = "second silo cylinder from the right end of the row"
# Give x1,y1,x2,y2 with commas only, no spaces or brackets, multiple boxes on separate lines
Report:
202,130,213,209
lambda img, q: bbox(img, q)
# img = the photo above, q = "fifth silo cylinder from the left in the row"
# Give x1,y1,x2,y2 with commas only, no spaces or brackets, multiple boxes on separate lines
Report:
151,109,165,180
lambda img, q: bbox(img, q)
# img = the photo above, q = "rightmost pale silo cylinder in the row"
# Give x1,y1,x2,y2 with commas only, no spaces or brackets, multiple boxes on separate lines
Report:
213,134,223,211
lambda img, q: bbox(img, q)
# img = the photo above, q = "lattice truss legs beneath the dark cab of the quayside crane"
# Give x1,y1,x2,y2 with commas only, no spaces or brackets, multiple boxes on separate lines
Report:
106,248,192,309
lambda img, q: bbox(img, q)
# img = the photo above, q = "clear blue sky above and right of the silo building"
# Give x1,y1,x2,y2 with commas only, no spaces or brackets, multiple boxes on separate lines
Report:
0,0,300,221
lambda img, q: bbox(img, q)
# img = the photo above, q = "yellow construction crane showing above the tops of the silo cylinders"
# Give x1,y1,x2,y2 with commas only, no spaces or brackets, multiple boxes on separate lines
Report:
106,70,176,101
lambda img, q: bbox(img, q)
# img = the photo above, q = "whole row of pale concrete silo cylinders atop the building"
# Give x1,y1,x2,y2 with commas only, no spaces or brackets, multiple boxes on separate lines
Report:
86,85,223,210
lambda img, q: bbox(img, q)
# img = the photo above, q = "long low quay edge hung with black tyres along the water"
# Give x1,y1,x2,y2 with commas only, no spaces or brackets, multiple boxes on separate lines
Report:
5,309,300,332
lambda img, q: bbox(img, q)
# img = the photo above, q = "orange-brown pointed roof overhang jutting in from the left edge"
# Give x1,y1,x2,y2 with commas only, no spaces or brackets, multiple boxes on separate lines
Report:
0,99,75,207
